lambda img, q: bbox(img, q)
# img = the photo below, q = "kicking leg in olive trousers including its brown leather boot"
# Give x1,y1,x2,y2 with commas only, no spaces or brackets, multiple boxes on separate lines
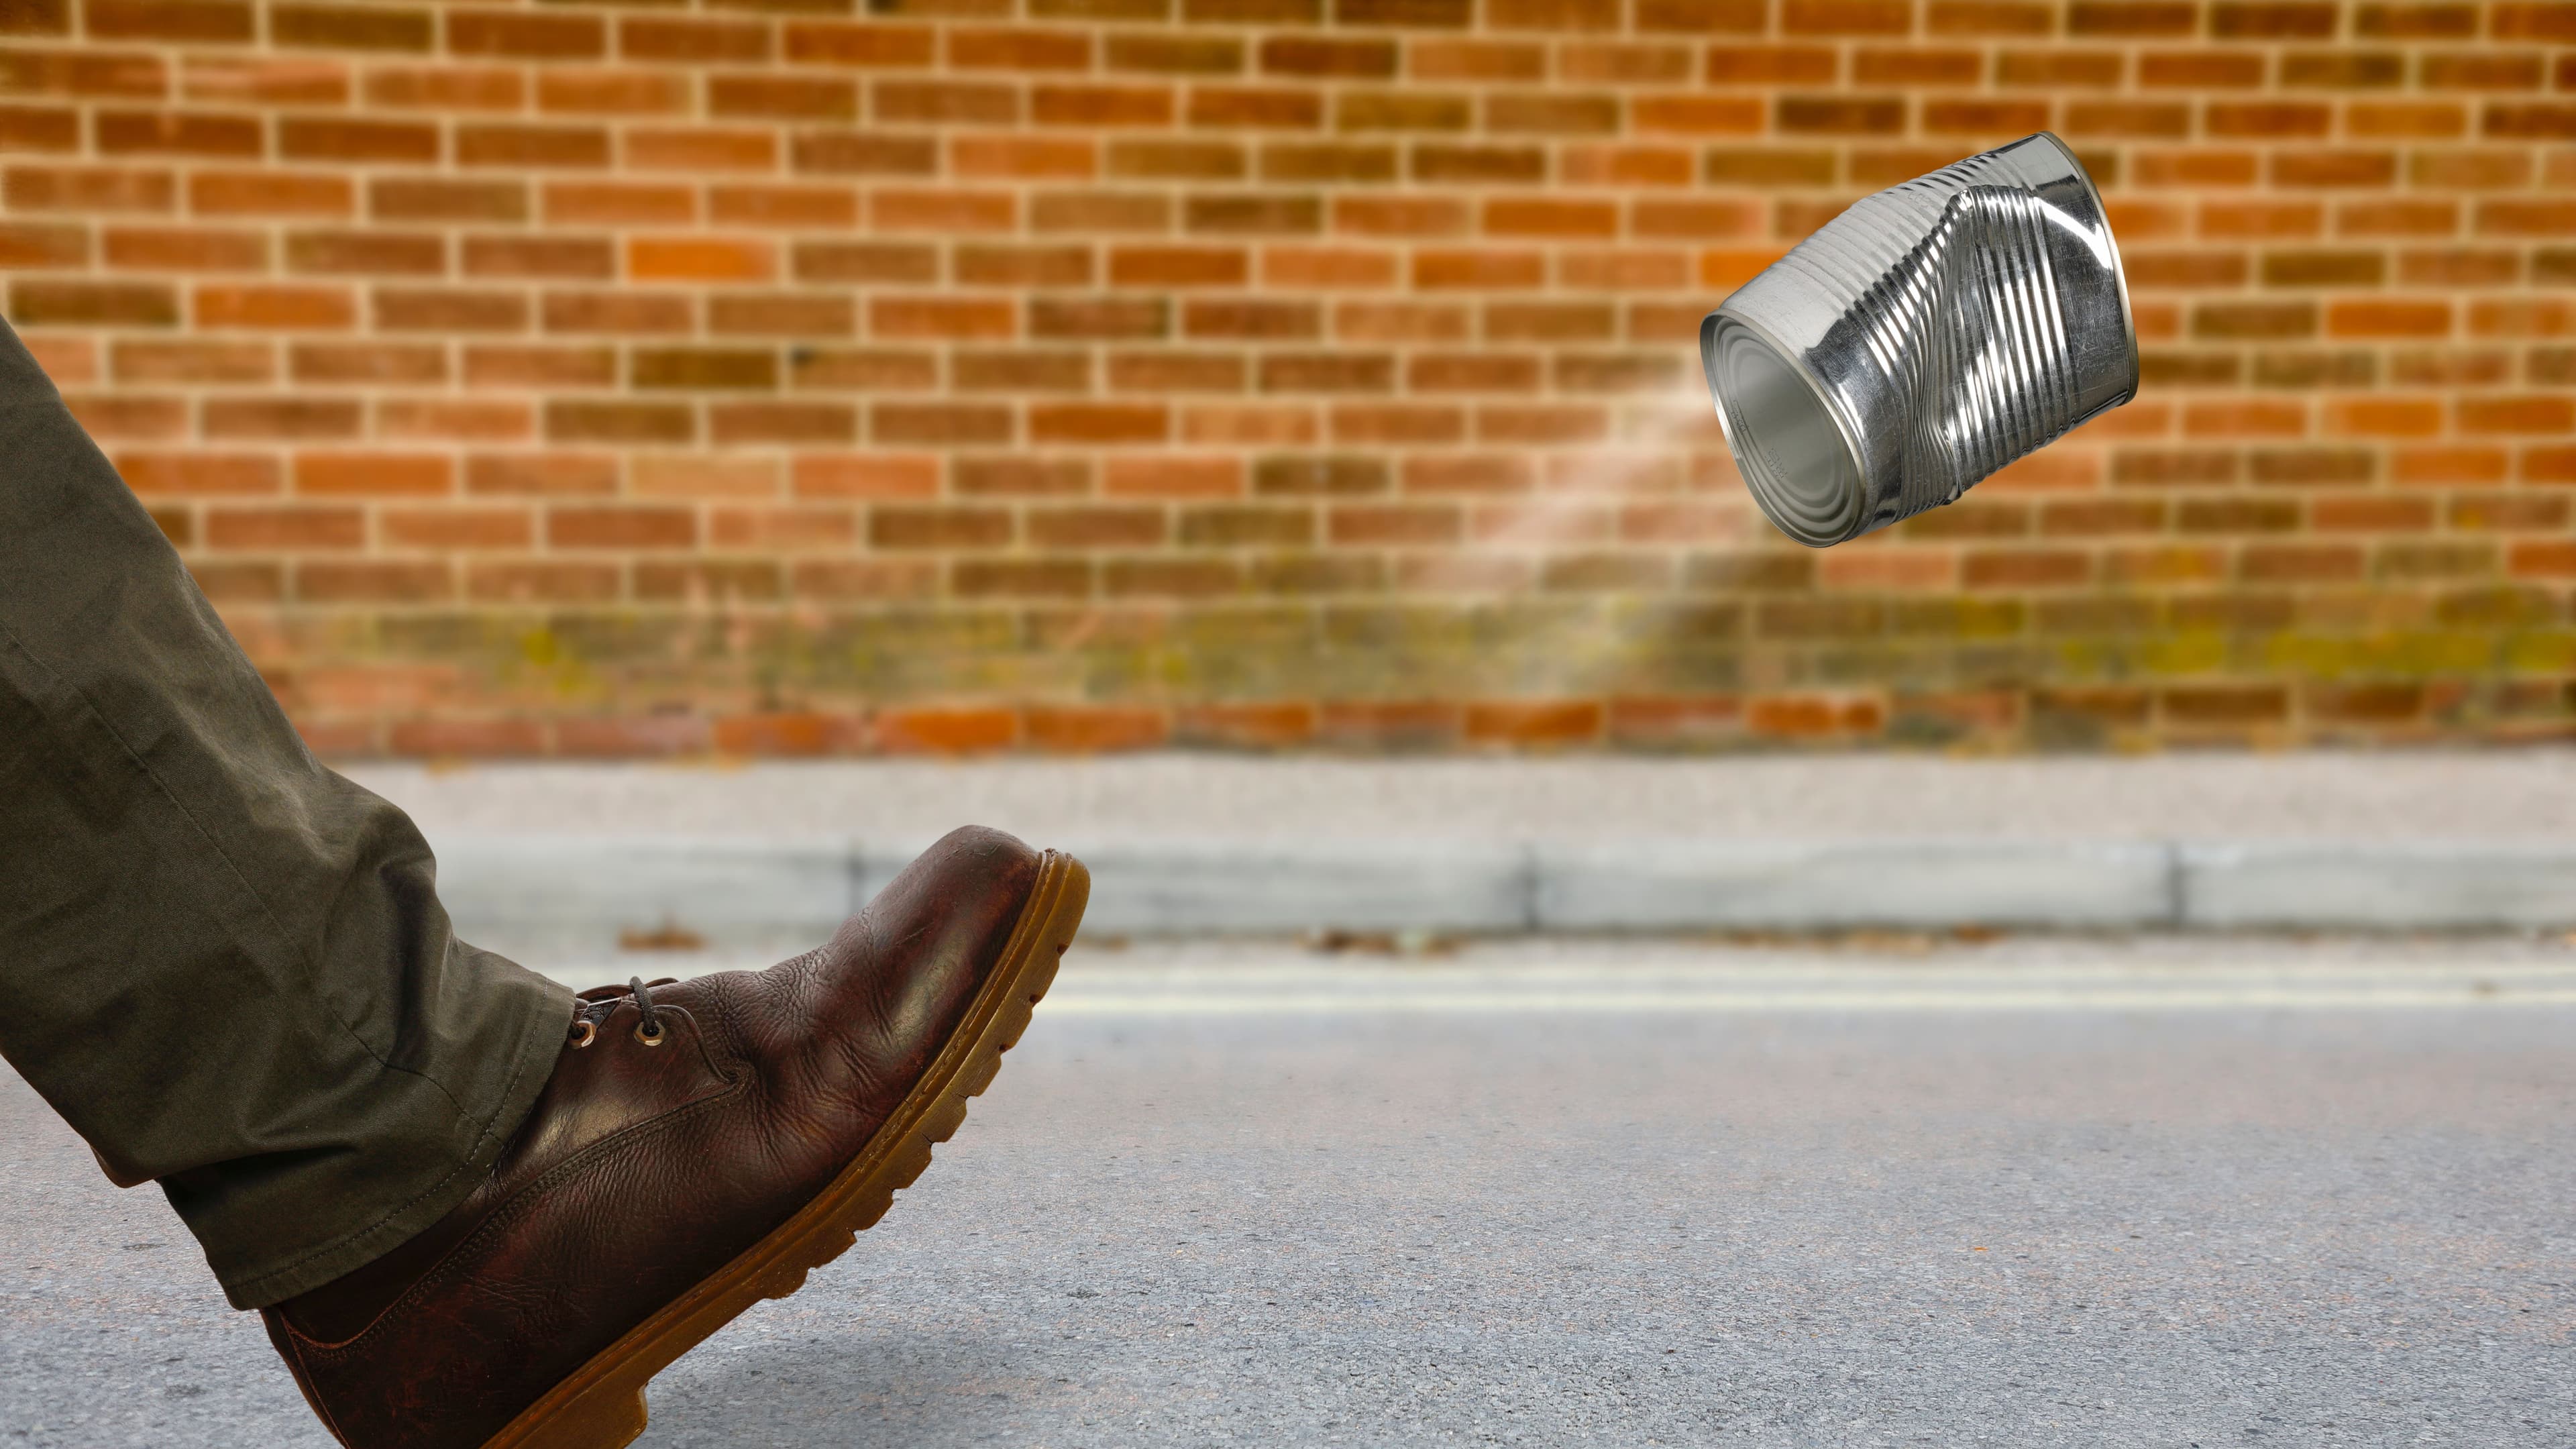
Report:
0,311,1089,1449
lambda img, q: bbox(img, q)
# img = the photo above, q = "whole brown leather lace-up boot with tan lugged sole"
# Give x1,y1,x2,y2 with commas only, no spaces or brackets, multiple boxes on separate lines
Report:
263,828,1089,1449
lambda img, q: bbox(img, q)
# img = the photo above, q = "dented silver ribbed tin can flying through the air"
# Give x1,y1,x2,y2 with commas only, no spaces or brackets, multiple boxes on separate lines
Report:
1700,131,2138,549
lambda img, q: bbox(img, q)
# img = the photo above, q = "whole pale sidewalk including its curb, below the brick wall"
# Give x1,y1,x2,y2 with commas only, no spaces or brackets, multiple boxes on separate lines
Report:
347,750,2576,951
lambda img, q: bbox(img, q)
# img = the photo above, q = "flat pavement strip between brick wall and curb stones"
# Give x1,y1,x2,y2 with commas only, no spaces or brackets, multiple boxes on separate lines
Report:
340,748,2576,843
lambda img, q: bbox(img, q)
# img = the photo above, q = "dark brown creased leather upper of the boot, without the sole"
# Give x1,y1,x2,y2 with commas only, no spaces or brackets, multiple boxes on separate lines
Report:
266,828,1038,1449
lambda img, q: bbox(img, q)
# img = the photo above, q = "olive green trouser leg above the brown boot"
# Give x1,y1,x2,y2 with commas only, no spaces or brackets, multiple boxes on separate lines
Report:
0,325,572,1307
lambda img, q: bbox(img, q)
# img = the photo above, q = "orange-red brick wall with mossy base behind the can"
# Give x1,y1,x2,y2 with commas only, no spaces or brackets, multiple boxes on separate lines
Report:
0,0,2576,755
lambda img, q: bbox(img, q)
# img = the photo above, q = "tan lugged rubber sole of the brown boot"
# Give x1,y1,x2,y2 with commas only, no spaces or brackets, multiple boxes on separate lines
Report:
484,851,1092,1449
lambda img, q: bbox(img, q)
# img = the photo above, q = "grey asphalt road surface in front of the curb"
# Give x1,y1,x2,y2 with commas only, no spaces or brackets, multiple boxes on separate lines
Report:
0,944,2576,1449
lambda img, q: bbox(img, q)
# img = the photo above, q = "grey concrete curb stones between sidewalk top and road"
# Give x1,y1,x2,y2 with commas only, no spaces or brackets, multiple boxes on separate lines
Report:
435,835,2576,951
